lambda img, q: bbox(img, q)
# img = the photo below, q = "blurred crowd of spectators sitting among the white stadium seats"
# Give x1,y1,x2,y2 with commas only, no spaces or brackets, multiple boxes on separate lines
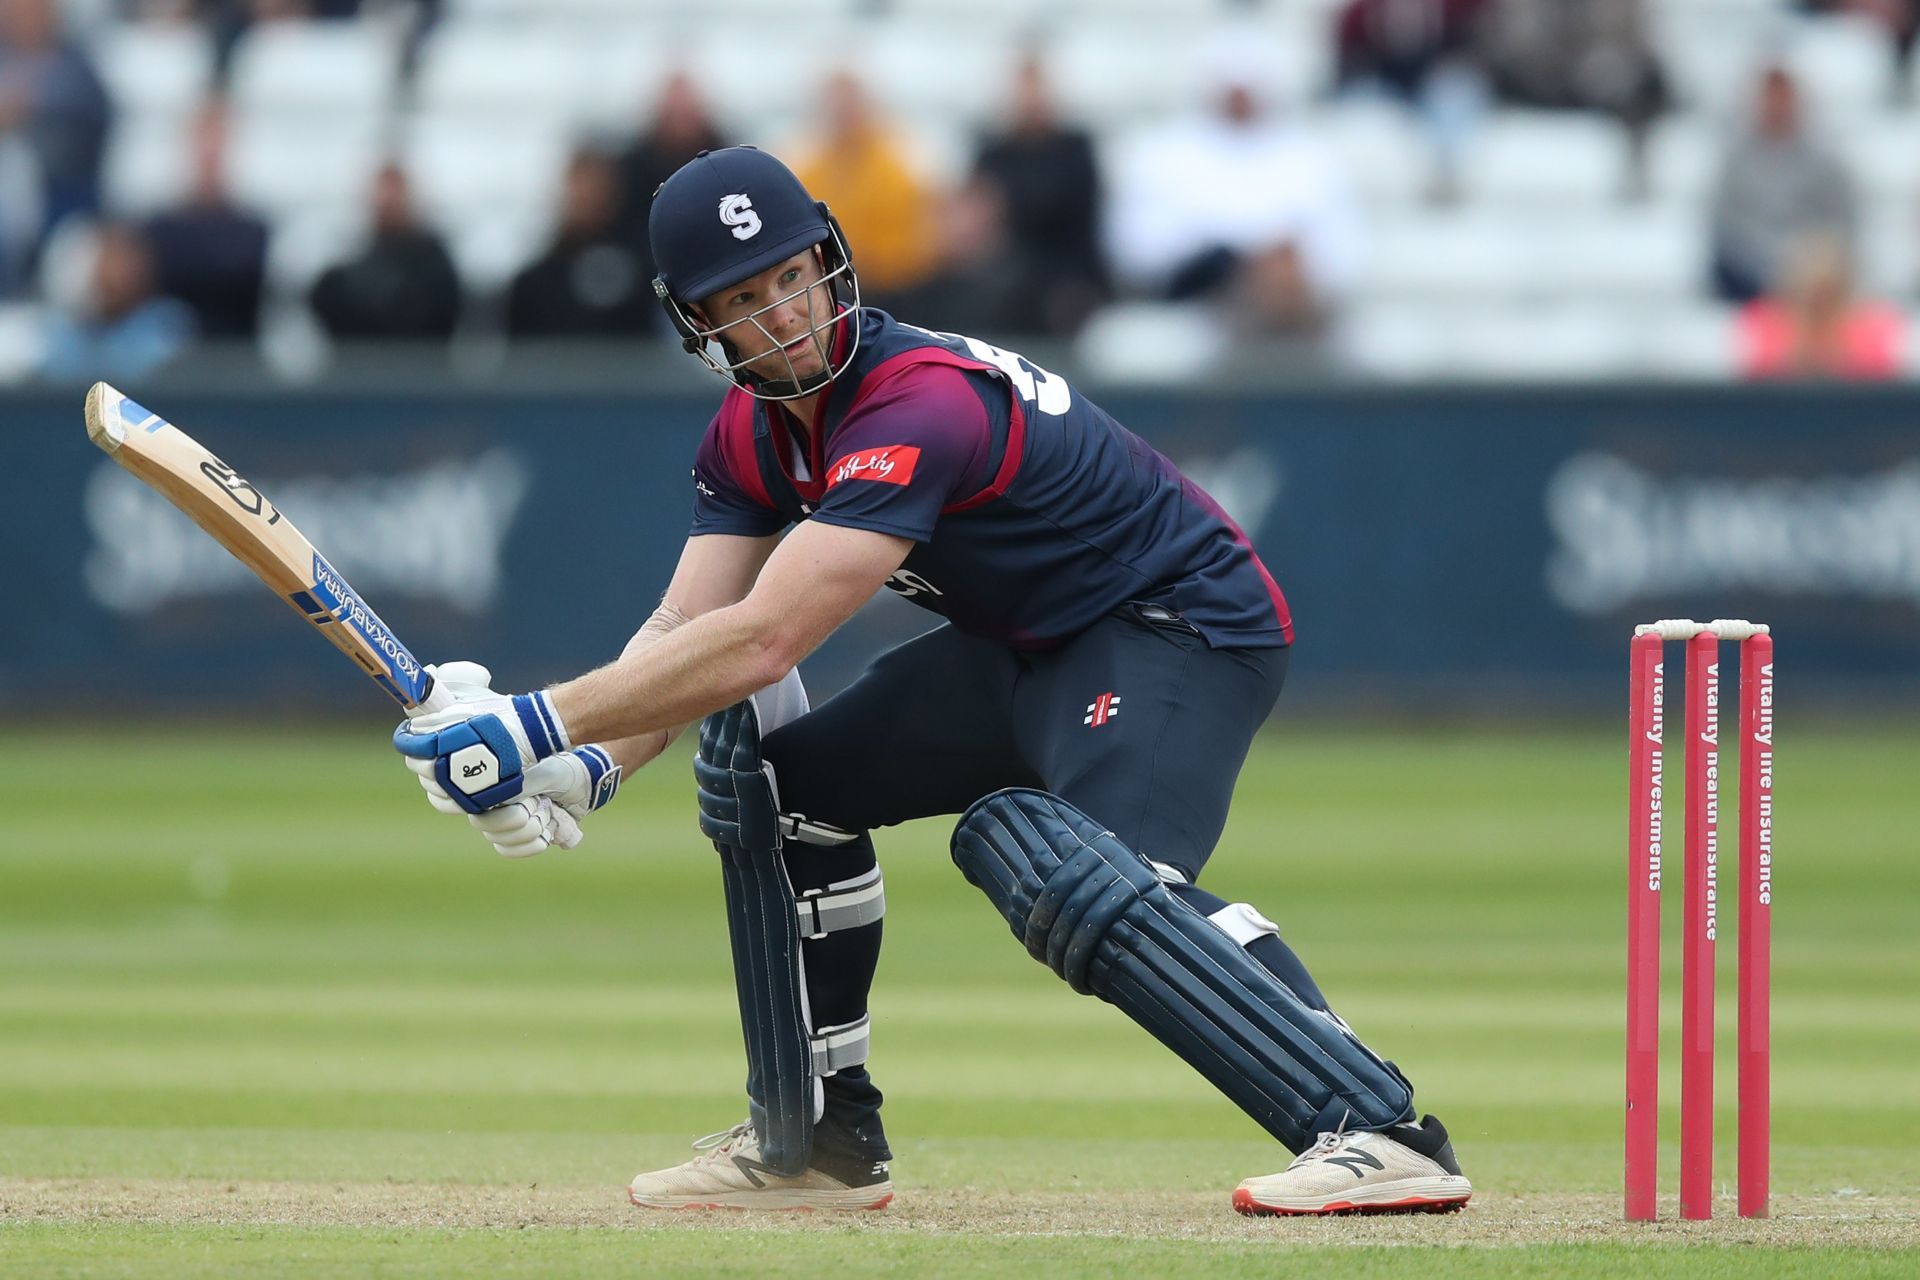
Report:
0,0,1920,378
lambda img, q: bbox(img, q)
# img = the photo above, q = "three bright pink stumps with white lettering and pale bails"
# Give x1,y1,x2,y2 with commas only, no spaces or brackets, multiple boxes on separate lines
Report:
1626,618,1774,1221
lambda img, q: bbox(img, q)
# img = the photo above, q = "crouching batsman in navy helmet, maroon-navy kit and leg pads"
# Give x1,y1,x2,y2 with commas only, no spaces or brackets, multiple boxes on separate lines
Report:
396,148,1473,1213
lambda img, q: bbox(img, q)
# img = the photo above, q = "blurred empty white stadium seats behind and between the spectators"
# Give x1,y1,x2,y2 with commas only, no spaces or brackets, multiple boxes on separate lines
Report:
52,0,1920,378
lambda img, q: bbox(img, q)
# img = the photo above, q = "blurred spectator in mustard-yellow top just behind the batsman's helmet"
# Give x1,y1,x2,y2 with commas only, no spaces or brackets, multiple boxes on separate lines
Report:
793,71,939,307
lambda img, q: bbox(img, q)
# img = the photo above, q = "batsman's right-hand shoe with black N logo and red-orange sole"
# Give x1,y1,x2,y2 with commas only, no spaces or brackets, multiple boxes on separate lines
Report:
1233,1115,1473,1215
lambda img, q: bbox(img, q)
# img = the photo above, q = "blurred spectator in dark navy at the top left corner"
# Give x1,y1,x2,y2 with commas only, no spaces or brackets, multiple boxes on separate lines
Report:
0,0,113,243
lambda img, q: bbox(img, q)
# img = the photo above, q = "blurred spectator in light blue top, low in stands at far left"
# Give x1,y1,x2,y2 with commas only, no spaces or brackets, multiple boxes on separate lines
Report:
44,223,196,380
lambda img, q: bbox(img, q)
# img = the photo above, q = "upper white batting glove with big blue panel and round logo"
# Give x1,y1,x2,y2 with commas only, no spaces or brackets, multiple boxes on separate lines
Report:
394,662,572,814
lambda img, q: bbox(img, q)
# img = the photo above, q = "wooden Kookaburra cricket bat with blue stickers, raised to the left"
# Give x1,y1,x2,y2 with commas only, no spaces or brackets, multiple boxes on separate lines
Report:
86,382,438,714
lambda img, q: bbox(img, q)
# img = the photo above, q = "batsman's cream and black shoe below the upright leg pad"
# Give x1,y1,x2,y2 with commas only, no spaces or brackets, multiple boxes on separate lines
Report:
626,1121,893,1209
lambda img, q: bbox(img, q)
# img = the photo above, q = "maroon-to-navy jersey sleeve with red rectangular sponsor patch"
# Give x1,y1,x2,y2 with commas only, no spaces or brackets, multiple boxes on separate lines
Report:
812,365,993,543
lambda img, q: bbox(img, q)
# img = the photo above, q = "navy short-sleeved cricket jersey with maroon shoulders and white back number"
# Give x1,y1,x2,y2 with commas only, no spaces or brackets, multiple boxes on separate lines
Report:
693,307,1294,649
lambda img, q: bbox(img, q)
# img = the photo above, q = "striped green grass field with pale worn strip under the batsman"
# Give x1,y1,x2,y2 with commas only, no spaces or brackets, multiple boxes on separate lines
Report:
0,723,1920,1276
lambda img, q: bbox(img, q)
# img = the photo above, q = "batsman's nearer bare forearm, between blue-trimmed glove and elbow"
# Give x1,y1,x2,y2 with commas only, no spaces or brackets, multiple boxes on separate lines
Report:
549,604,797,744
